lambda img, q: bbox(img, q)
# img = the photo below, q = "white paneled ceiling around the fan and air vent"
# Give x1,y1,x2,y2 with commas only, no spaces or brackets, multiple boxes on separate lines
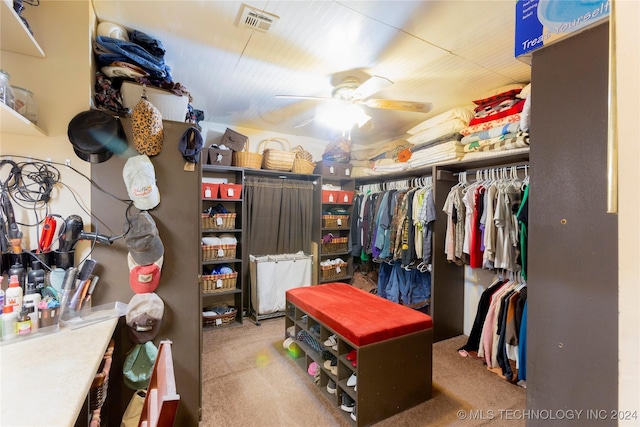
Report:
93,0,530,143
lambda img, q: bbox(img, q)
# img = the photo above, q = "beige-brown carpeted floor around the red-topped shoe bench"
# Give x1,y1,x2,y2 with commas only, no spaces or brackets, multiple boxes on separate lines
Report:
201,318,526,427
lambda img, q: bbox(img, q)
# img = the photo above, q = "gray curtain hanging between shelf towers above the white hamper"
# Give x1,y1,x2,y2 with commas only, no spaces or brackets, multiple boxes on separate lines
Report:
245,176,313,255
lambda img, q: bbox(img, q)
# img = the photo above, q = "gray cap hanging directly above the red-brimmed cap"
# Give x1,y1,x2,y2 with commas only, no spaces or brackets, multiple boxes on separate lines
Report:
124,211,164,265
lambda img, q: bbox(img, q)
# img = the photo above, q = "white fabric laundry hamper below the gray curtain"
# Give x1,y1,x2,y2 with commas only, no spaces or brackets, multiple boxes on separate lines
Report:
249,252,313,322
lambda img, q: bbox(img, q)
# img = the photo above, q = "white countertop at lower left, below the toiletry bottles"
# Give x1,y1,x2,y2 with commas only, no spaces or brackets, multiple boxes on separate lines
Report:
0,317,118,427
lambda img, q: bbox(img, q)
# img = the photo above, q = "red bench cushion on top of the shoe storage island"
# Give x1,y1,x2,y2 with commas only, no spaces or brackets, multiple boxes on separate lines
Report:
286,283,433,346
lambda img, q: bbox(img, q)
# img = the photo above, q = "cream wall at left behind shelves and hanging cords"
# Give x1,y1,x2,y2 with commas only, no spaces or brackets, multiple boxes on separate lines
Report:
0,1,94,253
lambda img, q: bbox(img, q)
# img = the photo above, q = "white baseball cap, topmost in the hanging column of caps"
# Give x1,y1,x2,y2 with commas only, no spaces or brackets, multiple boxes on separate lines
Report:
122,154,160,211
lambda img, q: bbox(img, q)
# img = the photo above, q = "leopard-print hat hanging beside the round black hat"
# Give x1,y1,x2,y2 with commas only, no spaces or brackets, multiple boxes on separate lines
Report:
131,85,164,156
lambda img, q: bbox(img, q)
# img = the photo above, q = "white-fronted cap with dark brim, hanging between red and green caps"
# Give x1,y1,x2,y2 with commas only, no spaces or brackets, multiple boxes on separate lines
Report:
126,292,164,344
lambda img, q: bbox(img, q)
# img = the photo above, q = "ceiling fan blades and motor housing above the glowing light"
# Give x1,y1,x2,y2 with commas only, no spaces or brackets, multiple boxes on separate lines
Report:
276,76,432,127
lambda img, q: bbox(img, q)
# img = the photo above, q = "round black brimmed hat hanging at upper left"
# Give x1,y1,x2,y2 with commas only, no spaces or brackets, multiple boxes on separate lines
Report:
67,110,128,163
